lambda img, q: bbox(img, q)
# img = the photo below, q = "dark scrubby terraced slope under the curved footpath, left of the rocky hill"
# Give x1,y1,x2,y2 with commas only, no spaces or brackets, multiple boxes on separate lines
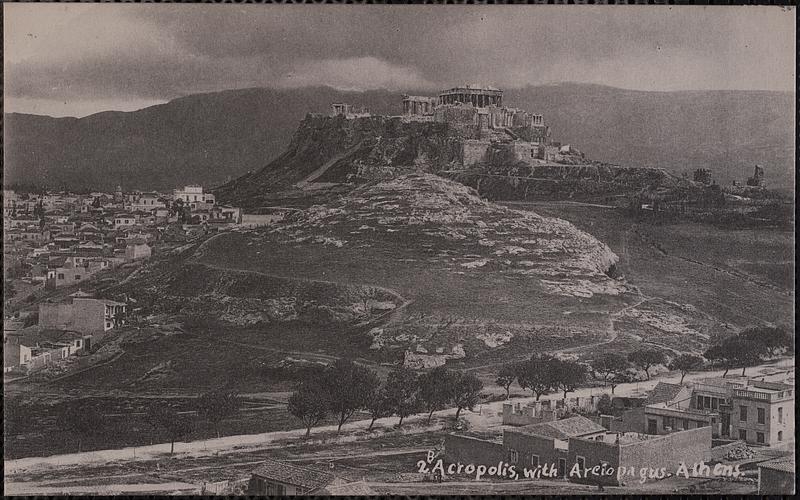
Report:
111,246,398,327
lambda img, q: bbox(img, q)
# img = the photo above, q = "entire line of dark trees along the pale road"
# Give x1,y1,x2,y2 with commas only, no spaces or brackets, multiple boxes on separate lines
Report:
34,327,794,453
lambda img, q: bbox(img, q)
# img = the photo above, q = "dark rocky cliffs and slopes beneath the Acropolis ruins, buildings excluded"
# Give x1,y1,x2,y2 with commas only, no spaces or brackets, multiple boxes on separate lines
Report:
215,115,691,207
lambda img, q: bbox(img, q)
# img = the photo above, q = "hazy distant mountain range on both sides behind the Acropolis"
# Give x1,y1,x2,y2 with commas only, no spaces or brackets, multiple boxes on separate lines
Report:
4,83,795,190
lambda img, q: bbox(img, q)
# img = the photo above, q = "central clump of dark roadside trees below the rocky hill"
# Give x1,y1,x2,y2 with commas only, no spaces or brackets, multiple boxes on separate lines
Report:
289,359,483,436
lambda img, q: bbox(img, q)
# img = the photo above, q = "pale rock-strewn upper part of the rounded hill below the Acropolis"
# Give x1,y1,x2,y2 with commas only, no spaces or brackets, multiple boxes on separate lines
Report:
271,174,623,286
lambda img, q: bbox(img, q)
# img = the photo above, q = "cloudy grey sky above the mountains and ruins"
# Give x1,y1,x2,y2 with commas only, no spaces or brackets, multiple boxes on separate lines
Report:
3,3,795,116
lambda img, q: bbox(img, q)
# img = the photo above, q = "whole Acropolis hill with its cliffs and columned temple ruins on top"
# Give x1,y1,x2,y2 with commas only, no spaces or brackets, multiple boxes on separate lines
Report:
216,85,700,206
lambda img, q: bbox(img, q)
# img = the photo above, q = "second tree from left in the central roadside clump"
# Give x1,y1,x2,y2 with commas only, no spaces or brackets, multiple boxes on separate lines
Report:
323,359,380,433
